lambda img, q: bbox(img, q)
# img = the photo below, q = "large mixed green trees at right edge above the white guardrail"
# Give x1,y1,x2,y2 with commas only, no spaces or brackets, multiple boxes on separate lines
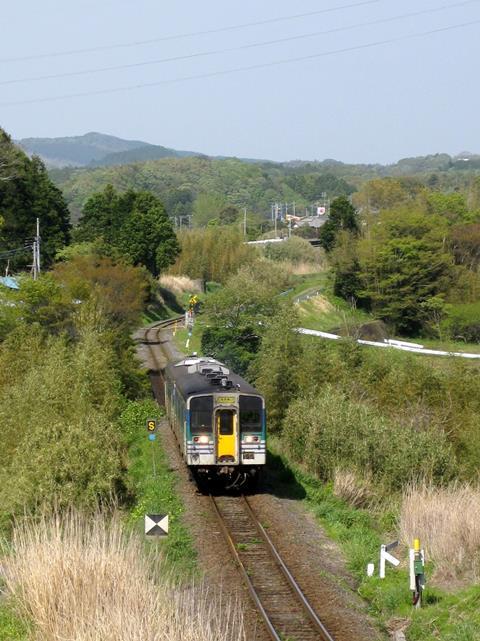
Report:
321,179,480,340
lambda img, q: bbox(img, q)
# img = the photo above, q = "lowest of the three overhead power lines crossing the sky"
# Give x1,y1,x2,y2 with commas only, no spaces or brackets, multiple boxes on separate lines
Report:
0,19,480,107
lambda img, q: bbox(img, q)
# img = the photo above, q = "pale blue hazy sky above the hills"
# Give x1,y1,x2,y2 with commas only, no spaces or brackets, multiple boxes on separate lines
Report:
0,0,480,163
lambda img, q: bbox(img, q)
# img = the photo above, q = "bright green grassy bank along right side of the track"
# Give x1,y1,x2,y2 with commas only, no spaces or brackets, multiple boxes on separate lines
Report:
269,438,480,641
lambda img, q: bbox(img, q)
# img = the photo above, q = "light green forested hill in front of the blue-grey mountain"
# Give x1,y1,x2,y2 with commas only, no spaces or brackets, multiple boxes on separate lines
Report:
50,158,355,220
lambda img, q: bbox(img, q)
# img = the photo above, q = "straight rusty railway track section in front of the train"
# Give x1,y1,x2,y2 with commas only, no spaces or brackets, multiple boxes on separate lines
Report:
210,495,334,641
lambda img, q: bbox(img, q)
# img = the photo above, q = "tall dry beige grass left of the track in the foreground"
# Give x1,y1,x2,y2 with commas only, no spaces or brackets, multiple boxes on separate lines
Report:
2,513,245,641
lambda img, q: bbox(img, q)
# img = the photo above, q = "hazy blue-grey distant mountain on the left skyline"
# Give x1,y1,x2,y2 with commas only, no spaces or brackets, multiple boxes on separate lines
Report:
16,132,201,168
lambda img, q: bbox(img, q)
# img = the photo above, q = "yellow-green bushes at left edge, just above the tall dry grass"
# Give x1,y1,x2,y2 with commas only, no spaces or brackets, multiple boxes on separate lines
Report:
0,322,123,515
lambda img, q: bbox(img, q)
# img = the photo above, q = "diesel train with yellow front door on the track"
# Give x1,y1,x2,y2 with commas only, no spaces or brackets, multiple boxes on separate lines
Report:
164,357,266,486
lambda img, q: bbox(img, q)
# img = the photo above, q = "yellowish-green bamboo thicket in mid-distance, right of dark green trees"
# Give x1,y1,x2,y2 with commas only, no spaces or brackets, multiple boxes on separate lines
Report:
169,227,257,283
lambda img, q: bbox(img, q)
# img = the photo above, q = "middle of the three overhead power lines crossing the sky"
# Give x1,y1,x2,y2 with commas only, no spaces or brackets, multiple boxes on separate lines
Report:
0,0,480,86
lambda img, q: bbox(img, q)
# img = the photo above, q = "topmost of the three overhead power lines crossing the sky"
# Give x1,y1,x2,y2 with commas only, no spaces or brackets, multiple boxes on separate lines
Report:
0,0,383,63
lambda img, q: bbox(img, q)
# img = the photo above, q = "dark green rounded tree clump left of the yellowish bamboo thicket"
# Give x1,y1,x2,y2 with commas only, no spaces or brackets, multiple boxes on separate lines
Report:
75,185,179,275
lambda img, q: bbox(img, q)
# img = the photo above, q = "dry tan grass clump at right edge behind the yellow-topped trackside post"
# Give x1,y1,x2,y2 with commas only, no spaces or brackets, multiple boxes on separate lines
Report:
400,485,480,579
